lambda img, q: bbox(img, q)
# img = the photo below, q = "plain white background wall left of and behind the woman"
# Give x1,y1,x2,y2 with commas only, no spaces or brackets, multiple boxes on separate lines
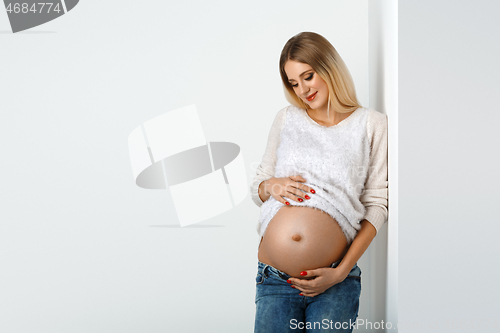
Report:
0,0,369,333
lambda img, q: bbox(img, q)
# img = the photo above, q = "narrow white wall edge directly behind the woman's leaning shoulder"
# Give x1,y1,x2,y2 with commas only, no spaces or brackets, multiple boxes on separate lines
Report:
366,0,398,332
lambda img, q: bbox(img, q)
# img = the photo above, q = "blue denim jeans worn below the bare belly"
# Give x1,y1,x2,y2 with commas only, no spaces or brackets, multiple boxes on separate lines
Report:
254,261,361,333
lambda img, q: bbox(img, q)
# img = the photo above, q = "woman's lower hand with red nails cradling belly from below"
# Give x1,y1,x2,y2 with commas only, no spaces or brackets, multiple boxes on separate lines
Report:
288,267,349,297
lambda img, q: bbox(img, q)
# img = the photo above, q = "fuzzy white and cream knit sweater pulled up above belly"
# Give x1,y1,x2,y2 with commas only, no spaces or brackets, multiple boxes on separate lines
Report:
250,105,388,244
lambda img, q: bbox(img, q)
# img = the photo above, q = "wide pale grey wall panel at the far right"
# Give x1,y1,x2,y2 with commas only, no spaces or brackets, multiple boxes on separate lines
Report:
398,0,500,333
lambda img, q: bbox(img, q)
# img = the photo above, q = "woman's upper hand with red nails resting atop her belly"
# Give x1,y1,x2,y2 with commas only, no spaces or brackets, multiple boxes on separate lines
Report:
261,175,315,205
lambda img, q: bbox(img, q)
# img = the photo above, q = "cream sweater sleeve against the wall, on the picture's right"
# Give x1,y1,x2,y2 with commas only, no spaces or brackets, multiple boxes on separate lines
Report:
360,109,389,233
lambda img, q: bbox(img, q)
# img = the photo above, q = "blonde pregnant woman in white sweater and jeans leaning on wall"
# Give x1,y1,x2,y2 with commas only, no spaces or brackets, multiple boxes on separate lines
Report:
251,32,388,333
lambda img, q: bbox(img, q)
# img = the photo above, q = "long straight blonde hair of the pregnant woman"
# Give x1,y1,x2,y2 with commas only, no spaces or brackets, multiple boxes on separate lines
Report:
280,31,361,113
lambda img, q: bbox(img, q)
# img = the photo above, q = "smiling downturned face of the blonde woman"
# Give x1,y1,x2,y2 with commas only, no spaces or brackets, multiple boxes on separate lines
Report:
284,60,328,110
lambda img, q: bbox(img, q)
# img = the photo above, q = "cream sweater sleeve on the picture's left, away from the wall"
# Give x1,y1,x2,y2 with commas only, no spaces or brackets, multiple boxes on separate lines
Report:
250,107,288,207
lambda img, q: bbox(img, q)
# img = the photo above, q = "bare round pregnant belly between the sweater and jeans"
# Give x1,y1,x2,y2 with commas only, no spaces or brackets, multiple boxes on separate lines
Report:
258,206,347,278
